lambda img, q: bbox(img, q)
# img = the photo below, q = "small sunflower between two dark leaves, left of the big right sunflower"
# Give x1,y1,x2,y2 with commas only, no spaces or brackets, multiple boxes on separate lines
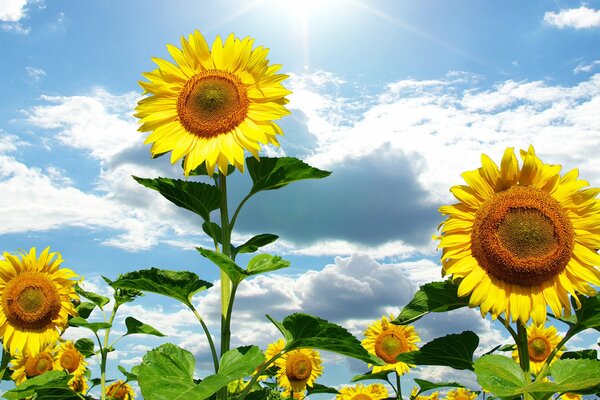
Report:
361,315,421,375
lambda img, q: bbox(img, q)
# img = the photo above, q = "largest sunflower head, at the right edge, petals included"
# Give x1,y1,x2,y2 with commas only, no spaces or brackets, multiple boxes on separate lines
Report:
438,146,600,325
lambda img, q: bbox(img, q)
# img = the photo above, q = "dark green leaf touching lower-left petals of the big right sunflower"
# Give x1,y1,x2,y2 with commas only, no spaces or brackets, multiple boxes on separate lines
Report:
392,280,469,325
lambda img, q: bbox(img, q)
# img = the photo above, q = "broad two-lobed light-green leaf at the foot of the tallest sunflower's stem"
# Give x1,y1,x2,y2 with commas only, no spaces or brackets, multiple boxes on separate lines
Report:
137,343,264,400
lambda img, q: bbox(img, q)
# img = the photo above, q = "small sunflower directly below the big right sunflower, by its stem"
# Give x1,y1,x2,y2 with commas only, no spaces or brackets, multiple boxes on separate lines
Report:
512,324,563,375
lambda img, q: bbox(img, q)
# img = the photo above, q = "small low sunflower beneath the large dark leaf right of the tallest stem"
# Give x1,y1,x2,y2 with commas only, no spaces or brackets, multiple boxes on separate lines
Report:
275,349,323,392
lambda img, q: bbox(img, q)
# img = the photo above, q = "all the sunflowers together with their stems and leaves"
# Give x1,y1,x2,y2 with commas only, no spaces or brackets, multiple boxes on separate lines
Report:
0,31,600,400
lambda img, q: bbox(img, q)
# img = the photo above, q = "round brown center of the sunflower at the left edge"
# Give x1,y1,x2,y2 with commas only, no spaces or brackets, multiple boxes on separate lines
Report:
2,272,60,329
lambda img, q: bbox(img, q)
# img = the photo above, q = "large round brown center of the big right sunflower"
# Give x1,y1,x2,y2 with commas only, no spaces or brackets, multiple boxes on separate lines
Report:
471,186,574,287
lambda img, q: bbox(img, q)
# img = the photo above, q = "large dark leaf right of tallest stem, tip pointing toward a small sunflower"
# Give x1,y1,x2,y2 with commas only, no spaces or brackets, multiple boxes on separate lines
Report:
267,313,378,364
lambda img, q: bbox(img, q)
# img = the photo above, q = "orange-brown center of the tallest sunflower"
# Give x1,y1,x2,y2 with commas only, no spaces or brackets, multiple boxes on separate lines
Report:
177,70,249,139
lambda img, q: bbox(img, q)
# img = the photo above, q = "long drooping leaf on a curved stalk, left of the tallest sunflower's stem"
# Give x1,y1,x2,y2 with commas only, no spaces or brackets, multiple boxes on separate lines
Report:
112,268,212,307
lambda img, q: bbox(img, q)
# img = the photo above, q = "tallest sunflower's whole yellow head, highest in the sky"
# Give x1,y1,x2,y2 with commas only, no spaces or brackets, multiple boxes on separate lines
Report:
135,30,291,176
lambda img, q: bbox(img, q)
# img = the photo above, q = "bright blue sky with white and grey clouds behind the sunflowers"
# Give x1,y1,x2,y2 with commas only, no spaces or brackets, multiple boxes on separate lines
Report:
0,0,600,400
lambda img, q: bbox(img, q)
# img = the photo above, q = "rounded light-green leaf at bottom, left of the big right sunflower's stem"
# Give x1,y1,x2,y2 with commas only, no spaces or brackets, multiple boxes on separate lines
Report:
473,354,525,397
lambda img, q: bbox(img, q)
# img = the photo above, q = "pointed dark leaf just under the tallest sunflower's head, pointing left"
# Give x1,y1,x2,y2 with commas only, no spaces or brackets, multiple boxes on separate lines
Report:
133,176,221,221
